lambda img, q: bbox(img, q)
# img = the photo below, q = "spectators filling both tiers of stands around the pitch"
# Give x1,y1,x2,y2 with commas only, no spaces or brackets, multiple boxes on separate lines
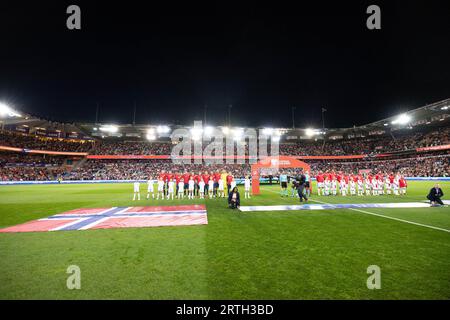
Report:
0,128,450,181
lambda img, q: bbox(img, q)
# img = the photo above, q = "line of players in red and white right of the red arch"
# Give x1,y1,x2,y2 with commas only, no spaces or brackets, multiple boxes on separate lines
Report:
316,172,408,196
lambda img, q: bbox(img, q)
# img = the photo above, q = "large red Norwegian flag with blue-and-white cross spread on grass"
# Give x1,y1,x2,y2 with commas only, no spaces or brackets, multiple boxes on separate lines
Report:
0,204,208,232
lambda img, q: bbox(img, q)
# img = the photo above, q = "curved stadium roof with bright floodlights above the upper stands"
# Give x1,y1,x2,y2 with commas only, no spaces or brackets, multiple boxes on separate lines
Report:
0,98,450,142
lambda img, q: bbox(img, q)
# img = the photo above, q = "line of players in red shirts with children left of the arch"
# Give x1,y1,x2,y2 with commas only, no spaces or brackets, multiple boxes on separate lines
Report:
133,171,251,200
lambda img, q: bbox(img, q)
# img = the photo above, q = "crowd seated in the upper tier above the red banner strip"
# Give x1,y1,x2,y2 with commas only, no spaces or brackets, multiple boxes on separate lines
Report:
0,128,450,156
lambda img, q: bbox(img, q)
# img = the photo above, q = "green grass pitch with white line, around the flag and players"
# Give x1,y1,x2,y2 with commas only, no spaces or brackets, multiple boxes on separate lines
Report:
0,182,450,299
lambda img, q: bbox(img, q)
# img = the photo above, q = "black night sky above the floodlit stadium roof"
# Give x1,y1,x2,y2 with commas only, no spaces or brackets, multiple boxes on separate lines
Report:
0,1,450,127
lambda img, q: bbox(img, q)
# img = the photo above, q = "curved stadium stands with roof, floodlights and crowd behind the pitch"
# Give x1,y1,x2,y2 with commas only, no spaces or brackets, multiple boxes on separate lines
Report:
0,99,450,181
